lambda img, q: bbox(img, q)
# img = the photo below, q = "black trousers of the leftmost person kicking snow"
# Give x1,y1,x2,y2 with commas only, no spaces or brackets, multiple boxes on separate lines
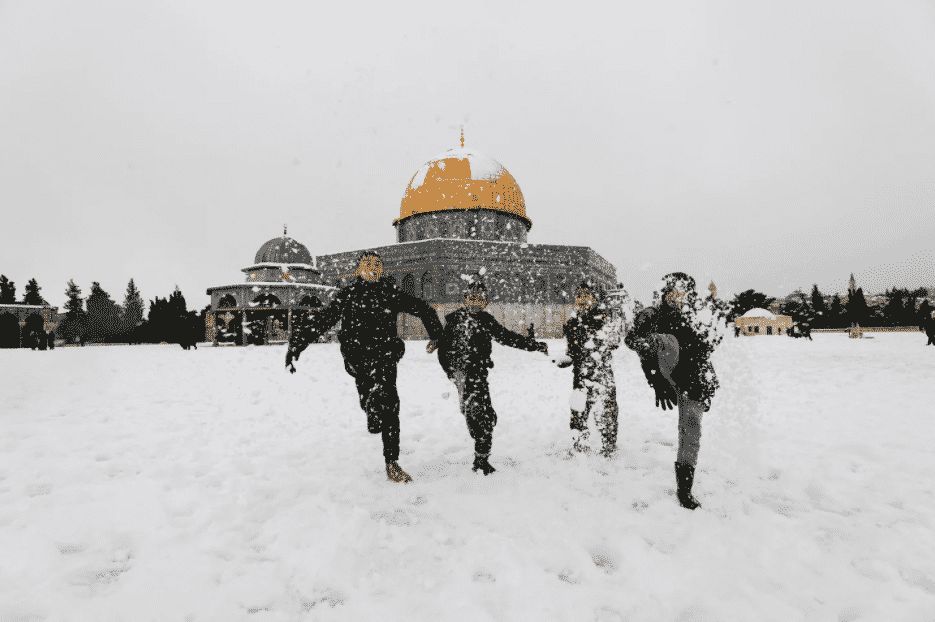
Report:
343,342,405,462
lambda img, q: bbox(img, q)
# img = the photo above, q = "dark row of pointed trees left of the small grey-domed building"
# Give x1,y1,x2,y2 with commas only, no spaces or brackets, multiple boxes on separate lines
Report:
0,275,211,345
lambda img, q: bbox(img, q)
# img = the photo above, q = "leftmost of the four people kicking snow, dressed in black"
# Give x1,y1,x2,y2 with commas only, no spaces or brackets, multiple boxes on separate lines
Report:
286,251,442,482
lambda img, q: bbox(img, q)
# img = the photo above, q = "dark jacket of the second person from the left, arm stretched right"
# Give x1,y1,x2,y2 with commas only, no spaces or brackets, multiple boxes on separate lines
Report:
438,307,539,377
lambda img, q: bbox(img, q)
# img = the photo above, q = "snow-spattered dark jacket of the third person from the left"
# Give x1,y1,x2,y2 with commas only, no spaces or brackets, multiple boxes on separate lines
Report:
562,306,620,387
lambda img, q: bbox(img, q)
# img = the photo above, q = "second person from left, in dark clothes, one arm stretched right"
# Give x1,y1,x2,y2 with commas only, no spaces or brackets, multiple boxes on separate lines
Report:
438,280,549,475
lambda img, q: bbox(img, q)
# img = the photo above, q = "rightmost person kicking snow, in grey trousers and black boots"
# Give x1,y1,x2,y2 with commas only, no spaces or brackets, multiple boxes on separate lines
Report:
624,272,725,510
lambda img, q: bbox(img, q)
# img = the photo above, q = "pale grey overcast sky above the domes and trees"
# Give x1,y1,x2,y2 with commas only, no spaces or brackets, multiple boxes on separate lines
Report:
0,0,935,308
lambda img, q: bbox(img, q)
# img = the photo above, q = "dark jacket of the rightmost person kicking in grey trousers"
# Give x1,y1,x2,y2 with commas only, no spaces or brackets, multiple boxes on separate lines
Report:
624,304,720,410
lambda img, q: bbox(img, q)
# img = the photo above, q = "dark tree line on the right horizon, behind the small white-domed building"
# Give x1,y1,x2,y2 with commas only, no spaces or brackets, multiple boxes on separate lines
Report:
728,285,935,328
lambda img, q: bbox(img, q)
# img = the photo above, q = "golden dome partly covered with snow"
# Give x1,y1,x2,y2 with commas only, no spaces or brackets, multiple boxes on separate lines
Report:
393,147,532,225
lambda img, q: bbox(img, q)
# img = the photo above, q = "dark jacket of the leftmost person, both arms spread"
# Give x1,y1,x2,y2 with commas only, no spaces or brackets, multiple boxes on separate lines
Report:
289,277,442,360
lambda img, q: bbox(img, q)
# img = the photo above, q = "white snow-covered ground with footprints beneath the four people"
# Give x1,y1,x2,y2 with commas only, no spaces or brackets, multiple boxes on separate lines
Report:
0,333,935,622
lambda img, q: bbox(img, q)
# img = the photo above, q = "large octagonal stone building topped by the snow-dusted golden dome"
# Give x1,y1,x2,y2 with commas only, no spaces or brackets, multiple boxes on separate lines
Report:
317,139,617,339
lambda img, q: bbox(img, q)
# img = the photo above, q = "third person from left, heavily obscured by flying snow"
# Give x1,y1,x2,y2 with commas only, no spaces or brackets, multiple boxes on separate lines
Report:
562,281,622,458
